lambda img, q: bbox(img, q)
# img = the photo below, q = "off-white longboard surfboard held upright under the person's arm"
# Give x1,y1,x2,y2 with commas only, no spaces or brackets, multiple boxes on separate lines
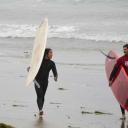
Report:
26,18,48,86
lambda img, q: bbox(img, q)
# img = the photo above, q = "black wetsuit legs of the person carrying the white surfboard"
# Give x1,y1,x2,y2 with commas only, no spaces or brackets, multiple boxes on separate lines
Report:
35,81,48,110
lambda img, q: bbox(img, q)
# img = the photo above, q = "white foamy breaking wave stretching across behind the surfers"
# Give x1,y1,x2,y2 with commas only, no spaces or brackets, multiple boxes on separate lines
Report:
0,24,128,42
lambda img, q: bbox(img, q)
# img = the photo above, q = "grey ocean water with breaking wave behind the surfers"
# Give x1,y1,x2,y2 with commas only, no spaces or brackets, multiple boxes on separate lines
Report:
0,0,128,73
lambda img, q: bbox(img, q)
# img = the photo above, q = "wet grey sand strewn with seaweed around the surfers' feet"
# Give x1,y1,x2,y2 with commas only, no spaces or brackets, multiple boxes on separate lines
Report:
0,66,127,128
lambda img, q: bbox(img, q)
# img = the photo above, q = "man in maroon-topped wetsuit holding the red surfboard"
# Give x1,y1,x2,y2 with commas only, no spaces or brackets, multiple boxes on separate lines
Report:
109,44,128,120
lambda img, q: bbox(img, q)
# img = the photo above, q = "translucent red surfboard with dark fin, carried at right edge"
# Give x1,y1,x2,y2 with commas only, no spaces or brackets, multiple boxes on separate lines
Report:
105,50,128,110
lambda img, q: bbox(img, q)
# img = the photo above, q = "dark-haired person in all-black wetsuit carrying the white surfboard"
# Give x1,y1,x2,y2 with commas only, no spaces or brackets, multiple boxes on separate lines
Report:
27,48,58,115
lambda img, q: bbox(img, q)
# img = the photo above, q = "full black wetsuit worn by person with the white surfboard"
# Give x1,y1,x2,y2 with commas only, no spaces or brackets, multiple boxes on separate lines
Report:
35,59,58,110
